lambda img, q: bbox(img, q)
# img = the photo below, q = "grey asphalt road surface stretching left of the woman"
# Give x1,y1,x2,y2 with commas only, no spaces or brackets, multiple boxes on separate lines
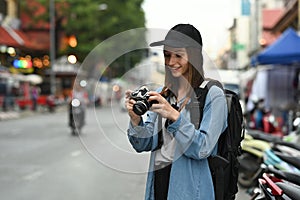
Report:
0,106,247,200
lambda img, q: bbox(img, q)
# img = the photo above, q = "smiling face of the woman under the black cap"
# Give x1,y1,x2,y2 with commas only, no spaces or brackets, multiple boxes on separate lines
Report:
164,46,189,77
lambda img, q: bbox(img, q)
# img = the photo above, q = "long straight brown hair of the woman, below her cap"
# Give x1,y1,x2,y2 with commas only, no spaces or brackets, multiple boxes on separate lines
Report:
165,47,204,96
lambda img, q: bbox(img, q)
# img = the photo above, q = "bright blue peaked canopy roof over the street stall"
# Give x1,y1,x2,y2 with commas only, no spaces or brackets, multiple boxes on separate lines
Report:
251,28,300,66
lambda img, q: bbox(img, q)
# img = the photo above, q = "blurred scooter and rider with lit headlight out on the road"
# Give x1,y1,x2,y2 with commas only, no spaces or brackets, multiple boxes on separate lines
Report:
69,98,85,135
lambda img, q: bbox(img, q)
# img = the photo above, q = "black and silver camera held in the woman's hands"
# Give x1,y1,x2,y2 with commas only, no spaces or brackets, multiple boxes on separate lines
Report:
130,86,158,115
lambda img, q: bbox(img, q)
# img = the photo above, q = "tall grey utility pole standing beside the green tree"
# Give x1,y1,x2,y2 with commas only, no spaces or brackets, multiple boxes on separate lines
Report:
49,0,56,95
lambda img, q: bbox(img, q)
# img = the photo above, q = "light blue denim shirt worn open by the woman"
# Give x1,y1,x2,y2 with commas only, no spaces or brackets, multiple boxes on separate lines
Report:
128,86,227,200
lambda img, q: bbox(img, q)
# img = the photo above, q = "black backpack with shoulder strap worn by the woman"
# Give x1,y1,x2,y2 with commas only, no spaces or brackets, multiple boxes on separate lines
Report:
186,80,244,200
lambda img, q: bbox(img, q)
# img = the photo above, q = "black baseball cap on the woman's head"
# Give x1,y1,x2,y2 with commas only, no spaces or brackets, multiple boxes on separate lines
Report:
150,24,202,49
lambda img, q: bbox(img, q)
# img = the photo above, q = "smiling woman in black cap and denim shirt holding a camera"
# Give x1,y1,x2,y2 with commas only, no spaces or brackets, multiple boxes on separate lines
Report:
125,24,227,200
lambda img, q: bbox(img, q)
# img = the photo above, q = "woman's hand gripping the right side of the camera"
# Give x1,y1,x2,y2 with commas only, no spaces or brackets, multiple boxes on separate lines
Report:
148,91,180,121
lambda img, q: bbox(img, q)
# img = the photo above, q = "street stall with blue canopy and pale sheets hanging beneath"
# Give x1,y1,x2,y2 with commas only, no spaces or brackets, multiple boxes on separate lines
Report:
247,28,300,132
